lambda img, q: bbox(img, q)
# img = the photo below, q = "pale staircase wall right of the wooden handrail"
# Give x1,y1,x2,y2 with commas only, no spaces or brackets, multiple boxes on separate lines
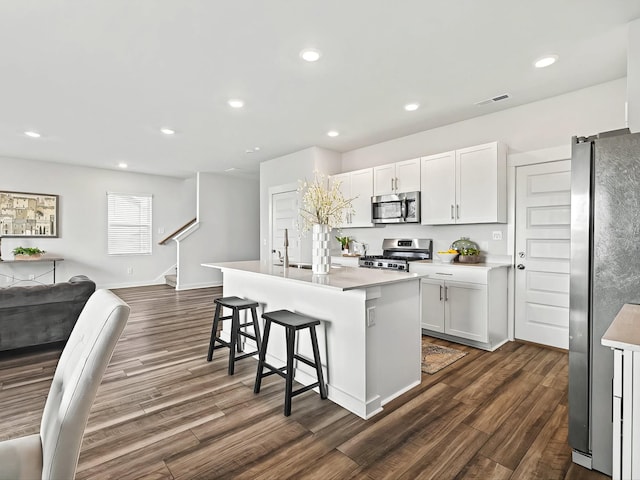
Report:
178,173,260,290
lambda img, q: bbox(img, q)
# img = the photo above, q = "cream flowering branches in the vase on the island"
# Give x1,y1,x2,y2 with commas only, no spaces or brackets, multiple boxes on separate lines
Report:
298,171,354,231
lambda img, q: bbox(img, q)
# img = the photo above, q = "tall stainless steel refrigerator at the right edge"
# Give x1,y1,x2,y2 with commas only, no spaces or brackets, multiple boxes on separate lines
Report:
569,129,640,475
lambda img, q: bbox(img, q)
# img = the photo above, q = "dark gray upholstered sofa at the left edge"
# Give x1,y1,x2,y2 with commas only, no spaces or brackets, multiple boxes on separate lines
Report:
0,275,96,350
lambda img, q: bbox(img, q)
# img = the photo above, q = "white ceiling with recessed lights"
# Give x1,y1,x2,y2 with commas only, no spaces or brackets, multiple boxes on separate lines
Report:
0,0,640,177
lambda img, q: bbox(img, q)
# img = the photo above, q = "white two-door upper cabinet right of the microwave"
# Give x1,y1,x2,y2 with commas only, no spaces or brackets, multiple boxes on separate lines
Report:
420,142,507,225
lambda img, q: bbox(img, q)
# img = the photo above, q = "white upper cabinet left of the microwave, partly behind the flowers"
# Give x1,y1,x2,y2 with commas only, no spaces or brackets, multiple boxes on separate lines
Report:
331,168,373,228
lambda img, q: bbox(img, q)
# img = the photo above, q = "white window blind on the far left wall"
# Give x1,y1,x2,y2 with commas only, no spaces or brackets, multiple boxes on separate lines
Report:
107,192,152,255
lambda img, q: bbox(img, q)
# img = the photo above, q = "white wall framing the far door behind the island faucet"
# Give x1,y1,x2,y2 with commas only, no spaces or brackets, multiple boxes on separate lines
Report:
260,147,342,260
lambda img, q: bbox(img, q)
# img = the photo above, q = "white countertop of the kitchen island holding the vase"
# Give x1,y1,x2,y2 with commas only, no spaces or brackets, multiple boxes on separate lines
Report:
202,260,422,290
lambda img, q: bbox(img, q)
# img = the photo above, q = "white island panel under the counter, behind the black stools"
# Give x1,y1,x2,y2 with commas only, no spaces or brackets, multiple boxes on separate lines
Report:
223,268,370,418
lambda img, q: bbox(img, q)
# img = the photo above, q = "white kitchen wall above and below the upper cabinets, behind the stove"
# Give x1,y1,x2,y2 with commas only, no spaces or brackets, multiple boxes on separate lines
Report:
336,78,626,261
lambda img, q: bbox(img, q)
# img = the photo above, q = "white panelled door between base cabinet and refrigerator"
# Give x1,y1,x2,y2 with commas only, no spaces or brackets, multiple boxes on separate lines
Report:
515,160,571,349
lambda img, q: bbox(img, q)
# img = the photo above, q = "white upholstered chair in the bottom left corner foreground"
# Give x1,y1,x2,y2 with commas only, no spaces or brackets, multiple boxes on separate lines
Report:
0,290,130,480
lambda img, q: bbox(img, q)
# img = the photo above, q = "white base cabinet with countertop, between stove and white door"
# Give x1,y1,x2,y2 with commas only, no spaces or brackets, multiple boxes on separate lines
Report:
411,262,508,351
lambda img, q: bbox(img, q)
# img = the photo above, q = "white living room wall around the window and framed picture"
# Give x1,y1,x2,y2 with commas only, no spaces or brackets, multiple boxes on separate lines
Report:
0,158,195,288
